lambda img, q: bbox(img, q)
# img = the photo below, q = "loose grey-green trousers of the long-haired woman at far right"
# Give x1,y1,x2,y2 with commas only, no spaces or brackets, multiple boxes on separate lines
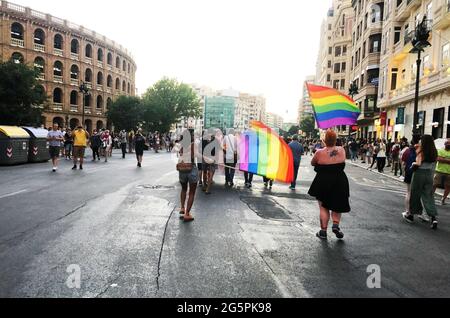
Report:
409,169,438,217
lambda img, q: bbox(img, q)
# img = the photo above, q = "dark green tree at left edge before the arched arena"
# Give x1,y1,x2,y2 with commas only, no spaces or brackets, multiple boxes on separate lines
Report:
0,61,47,126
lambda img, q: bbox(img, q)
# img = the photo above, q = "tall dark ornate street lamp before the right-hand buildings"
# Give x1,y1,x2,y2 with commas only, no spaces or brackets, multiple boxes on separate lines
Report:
409,16,431,142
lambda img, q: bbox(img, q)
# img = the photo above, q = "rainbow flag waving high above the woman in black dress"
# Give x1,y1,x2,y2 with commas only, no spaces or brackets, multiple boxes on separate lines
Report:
306,84,361,129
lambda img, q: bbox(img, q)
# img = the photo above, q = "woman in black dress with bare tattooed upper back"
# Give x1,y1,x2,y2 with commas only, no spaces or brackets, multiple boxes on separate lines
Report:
308,130,350,239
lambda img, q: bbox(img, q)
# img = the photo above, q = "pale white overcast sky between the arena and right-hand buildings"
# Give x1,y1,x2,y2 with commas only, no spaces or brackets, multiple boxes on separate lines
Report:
14,0,331,121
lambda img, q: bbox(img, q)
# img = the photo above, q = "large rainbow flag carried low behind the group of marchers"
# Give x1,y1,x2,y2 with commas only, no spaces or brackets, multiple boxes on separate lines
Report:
239,121,294,183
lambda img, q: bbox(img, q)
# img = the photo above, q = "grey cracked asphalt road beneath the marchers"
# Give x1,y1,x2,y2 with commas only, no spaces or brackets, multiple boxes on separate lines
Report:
0,153,450,298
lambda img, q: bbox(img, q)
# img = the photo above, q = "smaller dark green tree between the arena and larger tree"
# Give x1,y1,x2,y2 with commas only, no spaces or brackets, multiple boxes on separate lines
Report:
106,96,144,131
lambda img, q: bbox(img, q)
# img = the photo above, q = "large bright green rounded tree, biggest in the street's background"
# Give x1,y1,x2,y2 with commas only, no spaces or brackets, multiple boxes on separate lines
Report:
143,78,201,132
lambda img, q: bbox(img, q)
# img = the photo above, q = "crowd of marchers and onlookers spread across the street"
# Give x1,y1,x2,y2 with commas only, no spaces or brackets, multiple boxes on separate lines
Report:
44,124,450,239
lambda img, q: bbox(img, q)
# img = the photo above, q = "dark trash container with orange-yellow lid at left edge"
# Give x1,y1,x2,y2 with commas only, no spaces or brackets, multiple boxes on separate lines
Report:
0,126,30,166
